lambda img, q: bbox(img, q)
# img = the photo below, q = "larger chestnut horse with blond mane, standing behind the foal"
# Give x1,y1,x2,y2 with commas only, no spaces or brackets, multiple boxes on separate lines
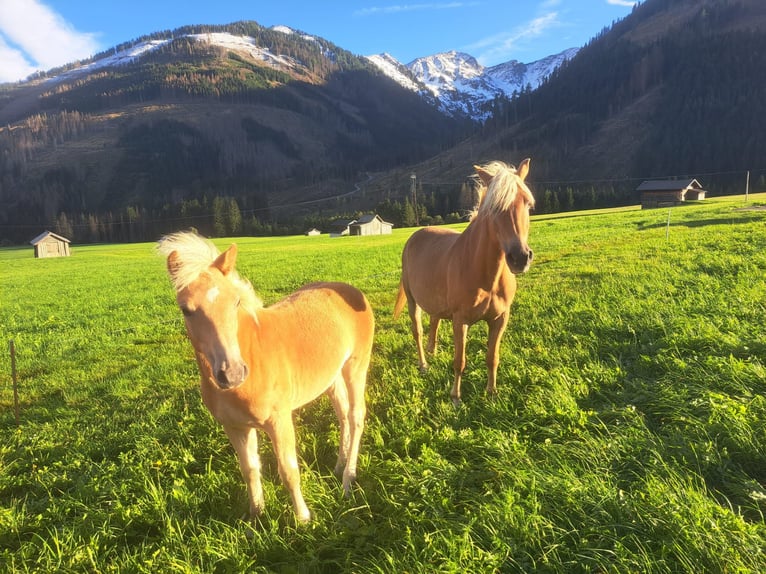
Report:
394,159,534,405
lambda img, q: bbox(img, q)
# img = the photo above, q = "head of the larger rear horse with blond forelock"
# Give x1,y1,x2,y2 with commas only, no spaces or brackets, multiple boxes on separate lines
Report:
474,158,535,273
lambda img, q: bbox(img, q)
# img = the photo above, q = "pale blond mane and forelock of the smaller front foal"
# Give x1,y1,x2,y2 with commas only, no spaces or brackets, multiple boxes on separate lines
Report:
157,231,263,313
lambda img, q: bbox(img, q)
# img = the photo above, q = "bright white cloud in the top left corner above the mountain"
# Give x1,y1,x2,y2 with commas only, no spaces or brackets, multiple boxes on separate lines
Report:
0,0,99,82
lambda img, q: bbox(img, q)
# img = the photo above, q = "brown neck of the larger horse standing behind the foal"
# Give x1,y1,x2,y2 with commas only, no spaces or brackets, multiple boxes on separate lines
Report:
459,215,507,291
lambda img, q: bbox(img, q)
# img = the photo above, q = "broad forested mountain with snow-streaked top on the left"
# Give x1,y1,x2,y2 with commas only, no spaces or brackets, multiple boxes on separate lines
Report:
0,22,466,241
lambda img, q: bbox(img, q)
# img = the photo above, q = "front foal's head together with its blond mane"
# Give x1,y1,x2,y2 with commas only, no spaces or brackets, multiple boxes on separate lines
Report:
158,232,261,389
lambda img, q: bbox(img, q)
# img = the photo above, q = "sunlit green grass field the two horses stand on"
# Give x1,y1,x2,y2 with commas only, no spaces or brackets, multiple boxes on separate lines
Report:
0,194,766,573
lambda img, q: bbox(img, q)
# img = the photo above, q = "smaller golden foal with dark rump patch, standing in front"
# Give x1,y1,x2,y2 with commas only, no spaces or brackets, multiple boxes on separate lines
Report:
158,232,375,522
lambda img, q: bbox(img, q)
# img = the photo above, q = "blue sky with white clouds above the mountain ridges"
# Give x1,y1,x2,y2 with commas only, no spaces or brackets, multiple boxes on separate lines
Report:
0,0,636,82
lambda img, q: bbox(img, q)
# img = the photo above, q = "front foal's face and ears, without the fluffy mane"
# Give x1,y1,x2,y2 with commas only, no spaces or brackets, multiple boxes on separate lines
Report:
165,236,248,389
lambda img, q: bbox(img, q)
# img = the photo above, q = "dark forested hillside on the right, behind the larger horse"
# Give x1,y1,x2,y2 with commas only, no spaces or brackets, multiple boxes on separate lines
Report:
476,0,766,204
